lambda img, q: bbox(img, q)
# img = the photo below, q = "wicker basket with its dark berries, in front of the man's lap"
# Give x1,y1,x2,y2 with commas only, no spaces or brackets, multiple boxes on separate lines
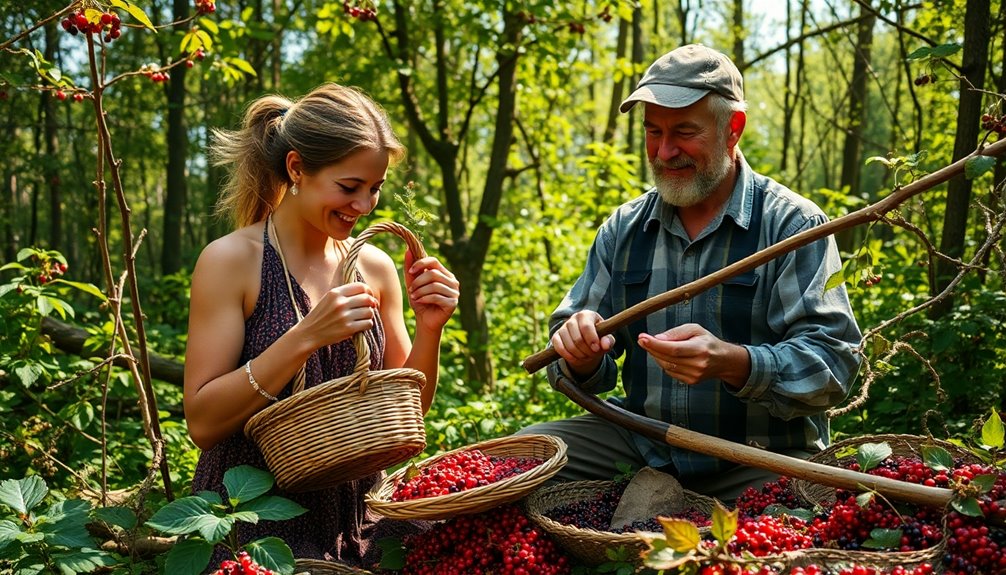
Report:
524,481,716,566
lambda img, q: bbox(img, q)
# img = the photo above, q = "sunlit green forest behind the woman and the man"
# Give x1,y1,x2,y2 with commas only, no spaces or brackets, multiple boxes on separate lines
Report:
0,0,1006,558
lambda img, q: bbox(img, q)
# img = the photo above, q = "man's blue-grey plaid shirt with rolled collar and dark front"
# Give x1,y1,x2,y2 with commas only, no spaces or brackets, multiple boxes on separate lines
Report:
548,155,861,476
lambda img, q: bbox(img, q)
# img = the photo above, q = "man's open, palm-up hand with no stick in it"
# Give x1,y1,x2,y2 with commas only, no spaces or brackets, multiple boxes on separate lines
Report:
639,324,750,389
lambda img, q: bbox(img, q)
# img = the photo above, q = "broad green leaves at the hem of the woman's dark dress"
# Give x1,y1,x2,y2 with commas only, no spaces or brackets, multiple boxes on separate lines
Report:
146,465,307,575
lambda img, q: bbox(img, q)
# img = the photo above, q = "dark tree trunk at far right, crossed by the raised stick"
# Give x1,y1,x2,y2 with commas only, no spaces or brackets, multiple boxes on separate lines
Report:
930,0,992,318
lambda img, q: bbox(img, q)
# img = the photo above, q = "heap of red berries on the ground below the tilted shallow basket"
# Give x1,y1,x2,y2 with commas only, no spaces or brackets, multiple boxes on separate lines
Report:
401,505,569,575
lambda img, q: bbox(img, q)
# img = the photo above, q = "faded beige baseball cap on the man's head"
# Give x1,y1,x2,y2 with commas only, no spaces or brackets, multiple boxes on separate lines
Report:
619,44,744,113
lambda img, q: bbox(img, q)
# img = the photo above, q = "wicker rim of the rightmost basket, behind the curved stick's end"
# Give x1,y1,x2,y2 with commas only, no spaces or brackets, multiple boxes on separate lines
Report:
793,434,980,507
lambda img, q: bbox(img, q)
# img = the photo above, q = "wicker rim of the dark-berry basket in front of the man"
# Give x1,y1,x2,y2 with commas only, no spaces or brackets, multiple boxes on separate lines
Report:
524,481,716,566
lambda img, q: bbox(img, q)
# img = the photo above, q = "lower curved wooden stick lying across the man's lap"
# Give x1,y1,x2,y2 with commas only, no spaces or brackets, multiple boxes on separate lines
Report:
555,377,954,508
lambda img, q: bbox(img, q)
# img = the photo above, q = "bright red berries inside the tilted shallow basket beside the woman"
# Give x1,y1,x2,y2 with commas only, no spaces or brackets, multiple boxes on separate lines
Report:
391,449,544,502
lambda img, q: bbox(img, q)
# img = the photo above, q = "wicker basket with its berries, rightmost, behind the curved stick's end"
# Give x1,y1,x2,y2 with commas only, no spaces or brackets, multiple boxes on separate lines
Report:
792,434,981,507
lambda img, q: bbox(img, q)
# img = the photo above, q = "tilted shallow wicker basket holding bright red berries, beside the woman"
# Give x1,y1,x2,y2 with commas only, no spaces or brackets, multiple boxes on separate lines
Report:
363,434,566,520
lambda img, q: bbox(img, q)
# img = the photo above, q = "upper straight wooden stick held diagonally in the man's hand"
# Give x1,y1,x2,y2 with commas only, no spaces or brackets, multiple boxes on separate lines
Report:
522,140,1006,373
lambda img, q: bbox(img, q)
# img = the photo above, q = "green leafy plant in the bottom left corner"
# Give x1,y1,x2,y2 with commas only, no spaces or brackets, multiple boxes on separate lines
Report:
0,475,123,575
